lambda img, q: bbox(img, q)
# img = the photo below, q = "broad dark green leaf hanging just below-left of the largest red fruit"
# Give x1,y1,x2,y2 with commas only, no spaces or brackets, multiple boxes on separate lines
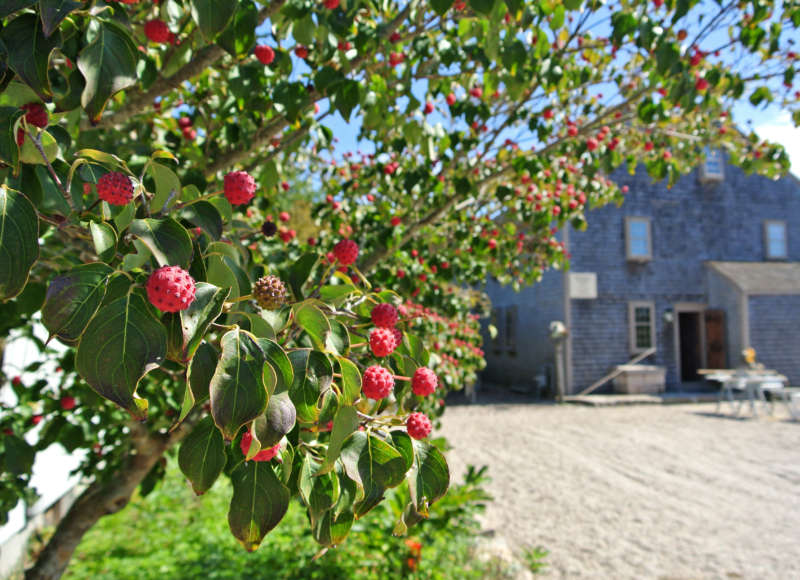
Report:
75,294,167,419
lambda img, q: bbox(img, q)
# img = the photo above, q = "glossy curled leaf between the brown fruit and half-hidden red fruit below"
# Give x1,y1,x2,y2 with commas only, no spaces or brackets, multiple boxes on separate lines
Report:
210,327,274,441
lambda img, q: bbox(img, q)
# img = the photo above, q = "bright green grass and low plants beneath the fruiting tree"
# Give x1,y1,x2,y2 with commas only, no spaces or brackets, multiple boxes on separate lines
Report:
59,463,511,580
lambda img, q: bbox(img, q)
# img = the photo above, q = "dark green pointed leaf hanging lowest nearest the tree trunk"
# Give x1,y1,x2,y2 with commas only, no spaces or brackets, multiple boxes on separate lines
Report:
178,417,227,495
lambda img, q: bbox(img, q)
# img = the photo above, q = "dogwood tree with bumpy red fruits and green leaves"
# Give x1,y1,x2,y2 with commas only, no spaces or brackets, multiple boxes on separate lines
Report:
0,0,800,578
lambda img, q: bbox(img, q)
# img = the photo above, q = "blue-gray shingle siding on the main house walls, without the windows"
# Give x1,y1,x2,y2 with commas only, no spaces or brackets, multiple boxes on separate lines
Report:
487,156,800,392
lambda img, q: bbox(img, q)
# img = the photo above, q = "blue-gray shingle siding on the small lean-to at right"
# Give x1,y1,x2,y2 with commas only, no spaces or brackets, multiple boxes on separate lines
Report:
749,296,800,385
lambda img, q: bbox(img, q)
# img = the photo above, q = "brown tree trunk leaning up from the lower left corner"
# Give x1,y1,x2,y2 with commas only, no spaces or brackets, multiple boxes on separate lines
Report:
25,421,194,580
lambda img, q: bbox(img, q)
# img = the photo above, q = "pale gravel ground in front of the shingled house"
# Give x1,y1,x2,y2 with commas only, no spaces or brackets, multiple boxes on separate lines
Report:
442,393,800,580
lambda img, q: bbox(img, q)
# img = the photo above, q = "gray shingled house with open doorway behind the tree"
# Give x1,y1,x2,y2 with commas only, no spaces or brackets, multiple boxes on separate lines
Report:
483,153,800,394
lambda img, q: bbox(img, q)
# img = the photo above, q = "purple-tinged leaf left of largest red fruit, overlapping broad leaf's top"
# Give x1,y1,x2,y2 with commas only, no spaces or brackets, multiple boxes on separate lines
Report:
42,262,114,344
